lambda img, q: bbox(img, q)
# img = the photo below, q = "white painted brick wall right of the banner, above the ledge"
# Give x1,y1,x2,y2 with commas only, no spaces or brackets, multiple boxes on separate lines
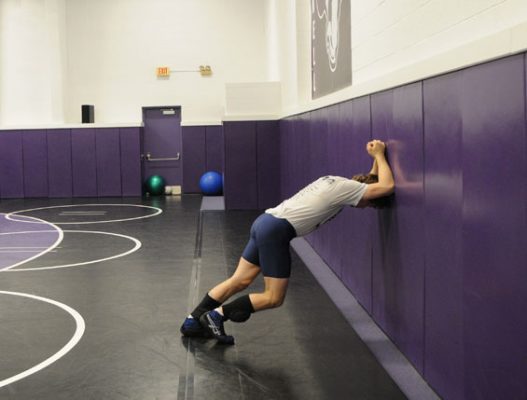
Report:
352,0,527,82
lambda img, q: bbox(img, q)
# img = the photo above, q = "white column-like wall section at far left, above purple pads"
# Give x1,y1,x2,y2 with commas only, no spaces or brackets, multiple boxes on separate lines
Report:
0,0,65,126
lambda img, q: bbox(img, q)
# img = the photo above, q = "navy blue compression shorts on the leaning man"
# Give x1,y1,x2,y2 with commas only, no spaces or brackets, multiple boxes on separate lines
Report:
242,213,296,278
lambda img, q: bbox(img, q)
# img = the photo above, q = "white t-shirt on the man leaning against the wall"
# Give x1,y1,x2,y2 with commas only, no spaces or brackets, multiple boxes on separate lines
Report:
265,176,366,236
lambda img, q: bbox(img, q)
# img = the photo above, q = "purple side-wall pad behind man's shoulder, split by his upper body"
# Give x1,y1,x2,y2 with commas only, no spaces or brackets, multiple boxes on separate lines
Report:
339,97,376,313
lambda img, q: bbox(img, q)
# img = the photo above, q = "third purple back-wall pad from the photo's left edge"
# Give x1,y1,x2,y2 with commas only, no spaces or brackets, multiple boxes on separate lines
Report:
47,129,73,197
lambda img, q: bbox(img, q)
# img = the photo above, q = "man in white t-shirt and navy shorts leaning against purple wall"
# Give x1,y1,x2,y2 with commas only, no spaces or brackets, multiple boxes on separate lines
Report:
181,140,395,344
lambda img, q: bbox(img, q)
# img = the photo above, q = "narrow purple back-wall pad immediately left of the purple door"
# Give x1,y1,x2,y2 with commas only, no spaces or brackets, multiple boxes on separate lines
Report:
119,128,142,196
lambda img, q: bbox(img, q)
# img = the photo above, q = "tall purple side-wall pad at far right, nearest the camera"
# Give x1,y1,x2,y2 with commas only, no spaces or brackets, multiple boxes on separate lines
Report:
460,55,527,399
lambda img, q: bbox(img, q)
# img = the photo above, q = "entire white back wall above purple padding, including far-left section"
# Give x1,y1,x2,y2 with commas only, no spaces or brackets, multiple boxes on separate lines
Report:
0,0,272,127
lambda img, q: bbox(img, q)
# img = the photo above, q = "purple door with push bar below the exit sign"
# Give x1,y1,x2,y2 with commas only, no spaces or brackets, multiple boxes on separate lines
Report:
143,107,182,185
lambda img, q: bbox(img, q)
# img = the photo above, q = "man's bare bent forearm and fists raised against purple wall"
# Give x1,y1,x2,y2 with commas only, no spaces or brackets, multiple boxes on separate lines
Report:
361,140,395,200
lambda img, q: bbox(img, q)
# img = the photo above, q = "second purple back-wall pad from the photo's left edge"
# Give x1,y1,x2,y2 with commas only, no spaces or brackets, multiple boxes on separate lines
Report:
22,130,49,197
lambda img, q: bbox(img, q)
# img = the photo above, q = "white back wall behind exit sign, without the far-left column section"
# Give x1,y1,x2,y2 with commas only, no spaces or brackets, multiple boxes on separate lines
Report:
66,0,269,124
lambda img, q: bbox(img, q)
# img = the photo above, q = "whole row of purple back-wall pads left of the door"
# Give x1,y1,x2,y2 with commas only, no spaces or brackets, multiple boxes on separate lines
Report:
4,128,141,198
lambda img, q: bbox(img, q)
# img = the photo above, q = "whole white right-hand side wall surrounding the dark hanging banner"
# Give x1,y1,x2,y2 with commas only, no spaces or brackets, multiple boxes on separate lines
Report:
282,0,527,115
